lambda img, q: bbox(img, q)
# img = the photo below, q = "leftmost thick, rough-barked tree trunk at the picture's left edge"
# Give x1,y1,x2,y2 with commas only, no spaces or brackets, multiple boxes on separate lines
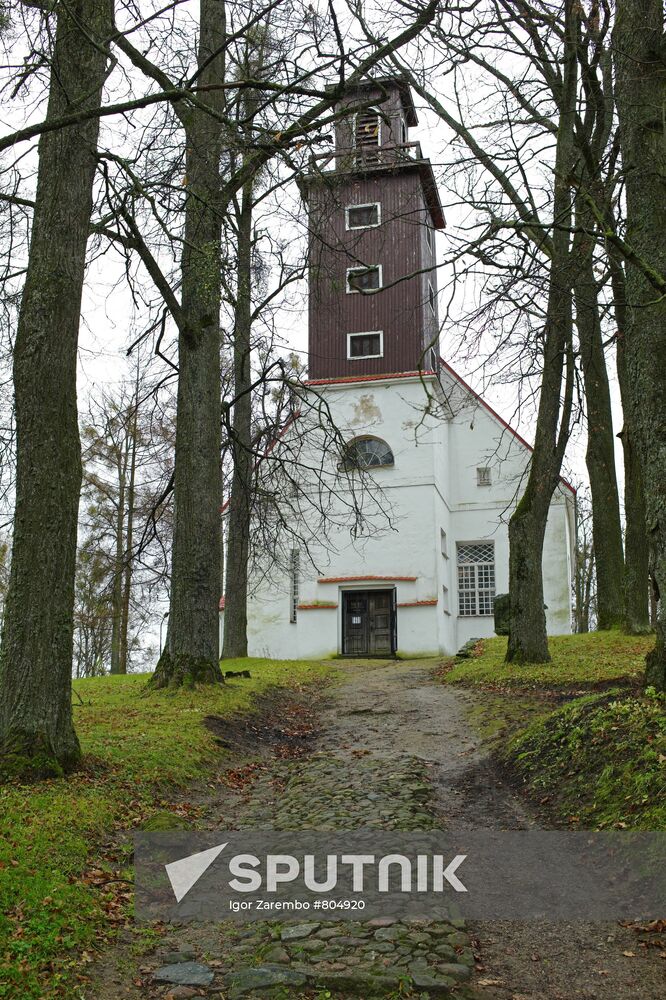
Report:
0,0,111,774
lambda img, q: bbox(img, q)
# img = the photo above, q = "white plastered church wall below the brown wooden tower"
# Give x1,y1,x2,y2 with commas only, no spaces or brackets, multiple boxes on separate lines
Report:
220,378,572,659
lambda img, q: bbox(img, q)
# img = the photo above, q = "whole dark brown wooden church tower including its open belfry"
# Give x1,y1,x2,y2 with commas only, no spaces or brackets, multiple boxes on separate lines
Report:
302,77,445,379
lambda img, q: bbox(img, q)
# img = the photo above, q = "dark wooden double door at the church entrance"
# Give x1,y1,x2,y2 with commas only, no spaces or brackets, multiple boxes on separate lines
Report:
342,590,397,656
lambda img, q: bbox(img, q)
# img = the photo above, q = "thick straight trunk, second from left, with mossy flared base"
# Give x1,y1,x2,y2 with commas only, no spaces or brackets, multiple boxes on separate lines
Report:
151,0,225,687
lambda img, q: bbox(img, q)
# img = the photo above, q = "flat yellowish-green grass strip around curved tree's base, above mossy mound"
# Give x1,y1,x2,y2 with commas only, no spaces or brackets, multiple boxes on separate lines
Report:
443,631,654,690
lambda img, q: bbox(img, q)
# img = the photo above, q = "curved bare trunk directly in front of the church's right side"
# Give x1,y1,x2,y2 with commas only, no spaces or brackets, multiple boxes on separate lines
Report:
506,0,579,663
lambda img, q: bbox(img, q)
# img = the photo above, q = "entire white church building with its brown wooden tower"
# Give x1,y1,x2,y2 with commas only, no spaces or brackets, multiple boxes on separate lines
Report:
220,78,575,659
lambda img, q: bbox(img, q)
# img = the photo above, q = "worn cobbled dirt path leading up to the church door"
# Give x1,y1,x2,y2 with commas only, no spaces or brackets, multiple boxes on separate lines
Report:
82,661,666,1000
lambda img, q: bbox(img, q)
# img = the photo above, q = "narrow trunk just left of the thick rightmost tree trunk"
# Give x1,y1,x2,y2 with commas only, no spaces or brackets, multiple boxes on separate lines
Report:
611,254,651,635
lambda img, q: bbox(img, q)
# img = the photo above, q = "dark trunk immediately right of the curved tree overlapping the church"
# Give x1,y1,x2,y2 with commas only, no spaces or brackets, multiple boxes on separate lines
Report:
573,213,624,629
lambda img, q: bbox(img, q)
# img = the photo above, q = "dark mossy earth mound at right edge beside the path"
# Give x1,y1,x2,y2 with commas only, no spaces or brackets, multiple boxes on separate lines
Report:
504,693,666,830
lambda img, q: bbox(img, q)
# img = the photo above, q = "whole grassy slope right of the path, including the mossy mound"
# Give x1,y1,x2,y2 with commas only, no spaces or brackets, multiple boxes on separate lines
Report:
443,632,666,830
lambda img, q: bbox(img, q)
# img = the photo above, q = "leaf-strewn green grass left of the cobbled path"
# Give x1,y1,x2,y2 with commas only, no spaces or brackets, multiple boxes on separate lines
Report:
0,660,335,1000
